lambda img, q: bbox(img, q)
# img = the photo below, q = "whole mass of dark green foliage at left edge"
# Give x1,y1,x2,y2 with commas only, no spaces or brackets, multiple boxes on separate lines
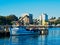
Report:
0,15,18,25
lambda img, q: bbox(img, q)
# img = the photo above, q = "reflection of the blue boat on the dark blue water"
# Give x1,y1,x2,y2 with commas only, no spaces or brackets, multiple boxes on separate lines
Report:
11,35,38,45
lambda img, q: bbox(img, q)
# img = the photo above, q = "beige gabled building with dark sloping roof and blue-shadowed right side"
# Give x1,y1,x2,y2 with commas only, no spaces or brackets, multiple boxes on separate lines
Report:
19,13,33,25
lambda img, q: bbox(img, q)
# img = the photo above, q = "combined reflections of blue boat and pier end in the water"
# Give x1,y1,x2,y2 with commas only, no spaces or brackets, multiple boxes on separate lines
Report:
10,35,47,45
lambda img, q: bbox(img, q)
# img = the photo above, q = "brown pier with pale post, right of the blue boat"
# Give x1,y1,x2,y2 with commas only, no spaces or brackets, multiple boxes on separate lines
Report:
26,25,48,35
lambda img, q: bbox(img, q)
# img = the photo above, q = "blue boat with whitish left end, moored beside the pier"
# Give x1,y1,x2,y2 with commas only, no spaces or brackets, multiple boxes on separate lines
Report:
10,26,40,35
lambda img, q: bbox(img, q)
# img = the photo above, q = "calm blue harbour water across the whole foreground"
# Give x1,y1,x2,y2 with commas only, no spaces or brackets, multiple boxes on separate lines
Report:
0,28,60,45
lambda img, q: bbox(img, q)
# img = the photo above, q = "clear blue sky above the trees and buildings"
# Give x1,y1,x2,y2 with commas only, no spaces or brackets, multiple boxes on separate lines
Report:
0,0,60,18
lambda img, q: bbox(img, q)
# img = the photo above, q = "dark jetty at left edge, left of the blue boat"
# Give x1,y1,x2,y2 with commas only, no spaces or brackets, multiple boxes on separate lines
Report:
0,25,10,37
